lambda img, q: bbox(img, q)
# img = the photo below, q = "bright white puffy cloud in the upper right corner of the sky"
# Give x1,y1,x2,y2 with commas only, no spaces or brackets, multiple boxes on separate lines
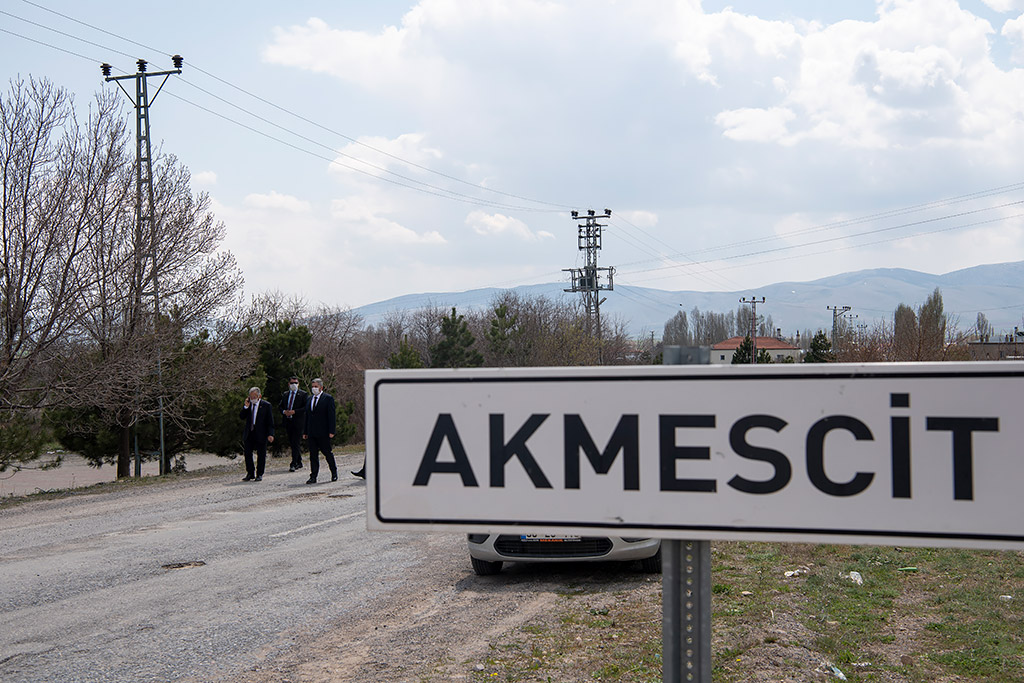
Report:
715,0,1024,153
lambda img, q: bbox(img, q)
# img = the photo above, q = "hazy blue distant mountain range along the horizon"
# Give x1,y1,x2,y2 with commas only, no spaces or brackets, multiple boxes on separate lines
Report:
355,261,1024,337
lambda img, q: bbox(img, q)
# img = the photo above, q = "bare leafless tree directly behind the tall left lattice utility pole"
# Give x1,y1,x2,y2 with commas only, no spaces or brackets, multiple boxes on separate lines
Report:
59,144,247,476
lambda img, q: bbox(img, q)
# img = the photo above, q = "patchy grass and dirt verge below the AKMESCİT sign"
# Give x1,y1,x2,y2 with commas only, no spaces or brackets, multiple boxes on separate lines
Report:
466,543,1024,683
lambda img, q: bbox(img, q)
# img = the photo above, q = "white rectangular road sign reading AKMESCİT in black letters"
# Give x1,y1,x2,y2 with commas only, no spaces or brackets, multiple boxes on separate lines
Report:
366,362,1024,549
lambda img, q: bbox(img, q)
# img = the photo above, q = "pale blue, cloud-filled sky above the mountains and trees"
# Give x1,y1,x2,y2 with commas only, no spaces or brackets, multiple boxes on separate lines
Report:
0,0,1024,325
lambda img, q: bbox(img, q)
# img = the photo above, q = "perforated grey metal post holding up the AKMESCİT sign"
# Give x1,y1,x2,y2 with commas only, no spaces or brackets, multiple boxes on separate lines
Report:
662,346,711,683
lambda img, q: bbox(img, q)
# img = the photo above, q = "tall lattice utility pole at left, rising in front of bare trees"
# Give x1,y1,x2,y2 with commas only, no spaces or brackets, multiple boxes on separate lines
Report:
99,54,183,476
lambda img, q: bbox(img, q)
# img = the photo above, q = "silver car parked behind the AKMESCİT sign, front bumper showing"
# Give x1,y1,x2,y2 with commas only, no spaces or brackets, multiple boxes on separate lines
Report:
467,533,662,577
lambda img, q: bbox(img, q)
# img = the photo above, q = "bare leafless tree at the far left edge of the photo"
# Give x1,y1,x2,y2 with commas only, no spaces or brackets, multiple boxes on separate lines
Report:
0,79,125,471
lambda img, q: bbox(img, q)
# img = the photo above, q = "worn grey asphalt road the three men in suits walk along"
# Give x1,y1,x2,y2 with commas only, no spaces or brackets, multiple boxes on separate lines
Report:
0,454,471,683
